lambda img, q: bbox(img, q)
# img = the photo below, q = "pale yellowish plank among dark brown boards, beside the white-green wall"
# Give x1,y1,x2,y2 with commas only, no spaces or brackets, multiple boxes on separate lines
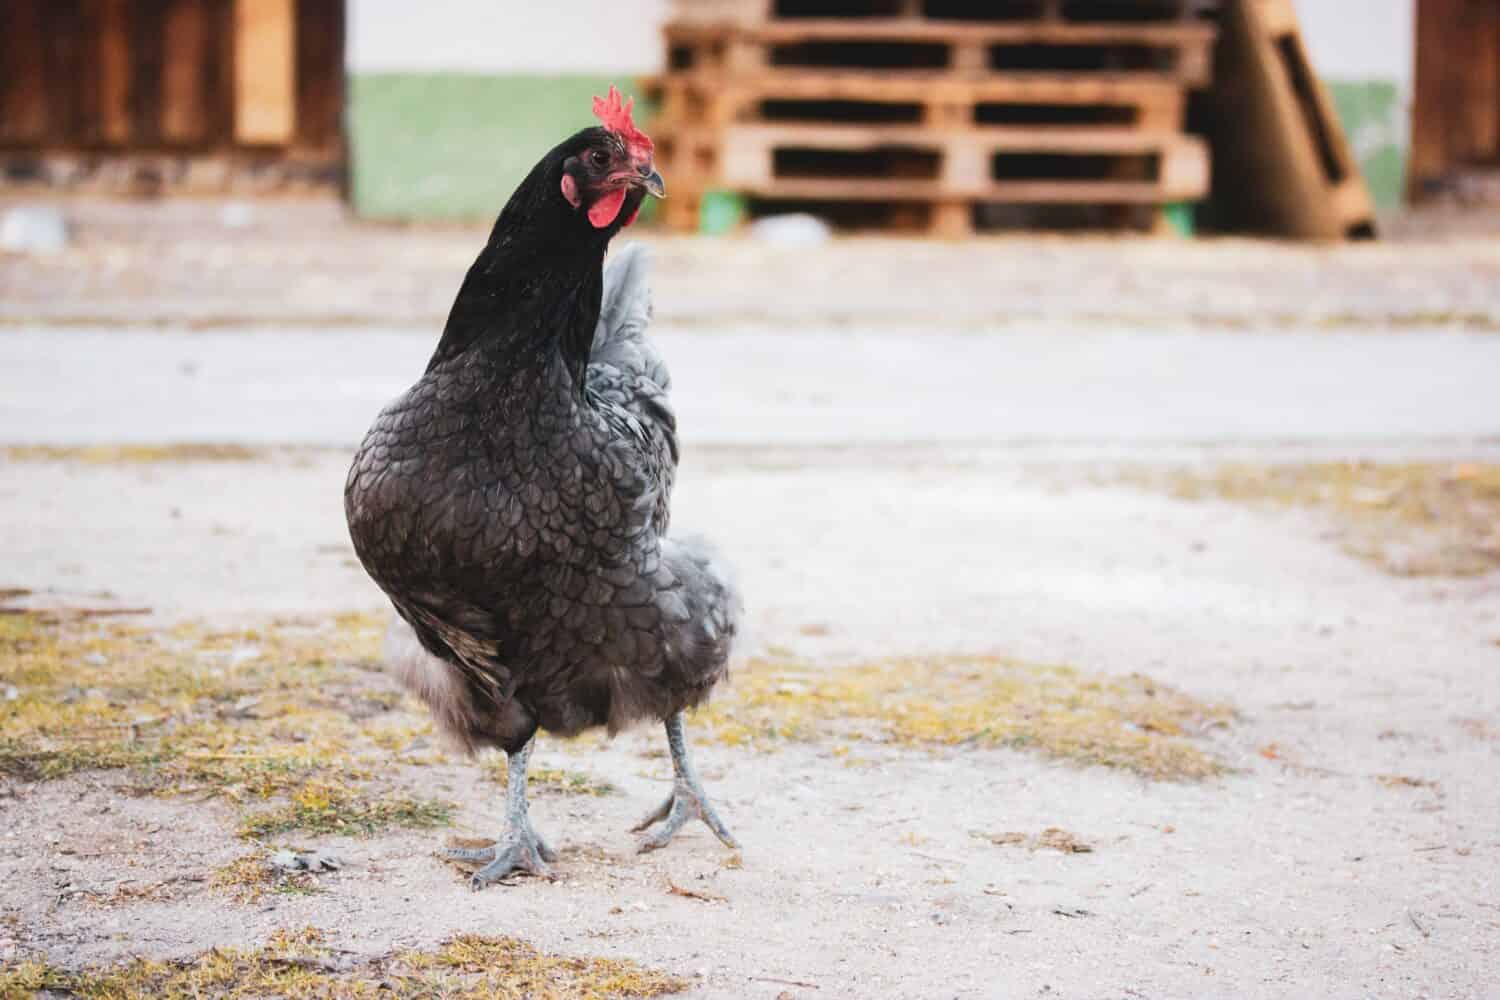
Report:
234,0,297,145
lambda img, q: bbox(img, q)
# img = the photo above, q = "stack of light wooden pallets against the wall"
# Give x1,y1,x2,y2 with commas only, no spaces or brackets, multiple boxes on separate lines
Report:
650,0,1215,235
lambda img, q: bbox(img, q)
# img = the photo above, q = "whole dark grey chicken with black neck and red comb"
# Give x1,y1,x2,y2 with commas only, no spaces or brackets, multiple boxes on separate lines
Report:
344,87,741,889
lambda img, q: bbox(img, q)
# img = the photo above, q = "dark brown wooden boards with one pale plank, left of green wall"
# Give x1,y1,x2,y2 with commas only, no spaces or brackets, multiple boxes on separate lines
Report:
0,0,345,193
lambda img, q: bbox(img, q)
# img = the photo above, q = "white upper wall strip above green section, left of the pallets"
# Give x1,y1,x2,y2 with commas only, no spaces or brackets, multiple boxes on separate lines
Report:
348,0,669,73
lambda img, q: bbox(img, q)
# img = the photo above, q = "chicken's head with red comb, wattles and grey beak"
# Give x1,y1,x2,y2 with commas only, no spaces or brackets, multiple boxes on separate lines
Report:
561,87,666,229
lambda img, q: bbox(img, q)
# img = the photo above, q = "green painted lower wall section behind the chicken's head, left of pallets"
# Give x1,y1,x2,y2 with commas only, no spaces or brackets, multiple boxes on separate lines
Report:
348,73,657,219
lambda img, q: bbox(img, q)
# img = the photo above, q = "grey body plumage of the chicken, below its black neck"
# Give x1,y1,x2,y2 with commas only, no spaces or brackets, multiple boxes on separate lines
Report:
345,246,741,750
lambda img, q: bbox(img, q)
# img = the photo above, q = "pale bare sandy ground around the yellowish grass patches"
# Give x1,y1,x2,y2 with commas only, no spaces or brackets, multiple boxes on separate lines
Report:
0,199,1500,999
